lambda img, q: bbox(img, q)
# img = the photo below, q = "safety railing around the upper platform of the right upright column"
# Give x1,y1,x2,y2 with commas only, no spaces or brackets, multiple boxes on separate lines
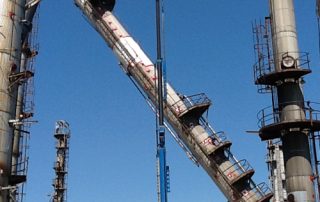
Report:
253,52,310,81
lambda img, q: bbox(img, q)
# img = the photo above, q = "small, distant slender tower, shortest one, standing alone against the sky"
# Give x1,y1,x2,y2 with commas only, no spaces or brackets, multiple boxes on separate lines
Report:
52,121,70,202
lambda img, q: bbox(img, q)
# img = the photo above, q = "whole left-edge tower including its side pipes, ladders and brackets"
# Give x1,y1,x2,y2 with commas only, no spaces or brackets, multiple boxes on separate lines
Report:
0,0,39,202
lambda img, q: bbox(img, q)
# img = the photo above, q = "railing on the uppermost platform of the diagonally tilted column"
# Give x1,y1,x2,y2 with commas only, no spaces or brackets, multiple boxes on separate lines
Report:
172,93,211,115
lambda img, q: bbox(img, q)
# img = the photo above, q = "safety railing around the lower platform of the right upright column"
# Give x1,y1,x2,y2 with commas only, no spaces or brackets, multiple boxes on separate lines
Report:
257,101,320,128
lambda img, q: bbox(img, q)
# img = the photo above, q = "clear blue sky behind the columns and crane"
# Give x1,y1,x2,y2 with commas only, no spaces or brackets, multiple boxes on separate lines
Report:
26,0,320,202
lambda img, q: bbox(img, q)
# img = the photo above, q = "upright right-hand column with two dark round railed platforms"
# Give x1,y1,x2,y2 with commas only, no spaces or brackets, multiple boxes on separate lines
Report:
255,0,320,202
